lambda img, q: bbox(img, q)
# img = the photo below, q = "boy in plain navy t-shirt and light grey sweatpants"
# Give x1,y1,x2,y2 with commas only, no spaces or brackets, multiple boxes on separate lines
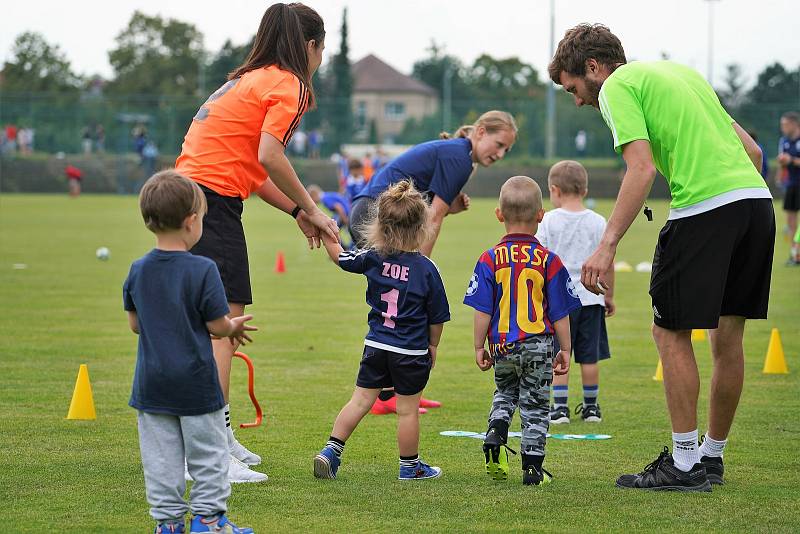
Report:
122,170,256,534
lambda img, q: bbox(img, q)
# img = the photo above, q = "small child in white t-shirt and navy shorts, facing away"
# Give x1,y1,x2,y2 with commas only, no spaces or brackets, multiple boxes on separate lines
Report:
536,161,615,424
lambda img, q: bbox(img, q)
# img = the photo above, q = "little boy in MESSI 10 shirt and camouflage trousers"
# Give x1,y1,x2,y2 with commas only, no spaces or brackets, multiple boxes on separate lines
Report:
464,176,581,485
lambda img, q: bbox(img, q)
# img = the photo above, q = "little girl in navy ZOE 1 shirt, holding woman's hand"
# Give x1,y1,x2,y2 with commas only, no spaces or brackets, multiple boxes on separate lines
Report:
314,180,450,480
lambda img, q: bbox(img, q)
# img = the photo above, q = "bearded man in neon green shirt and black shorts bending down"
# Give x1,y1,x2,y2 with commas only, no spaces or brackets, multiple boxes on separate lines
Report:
548,24,775,491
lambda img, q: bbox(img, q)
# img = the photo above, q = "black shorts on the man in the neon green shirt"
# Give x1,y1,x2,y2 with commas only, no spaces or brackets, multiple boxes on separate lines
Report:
650,198,775,330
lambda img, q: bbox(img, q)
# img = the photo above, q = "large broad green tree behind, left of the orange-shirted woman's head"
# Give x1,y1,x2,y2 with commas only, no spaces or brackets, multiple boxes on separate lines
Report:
108,11,205,96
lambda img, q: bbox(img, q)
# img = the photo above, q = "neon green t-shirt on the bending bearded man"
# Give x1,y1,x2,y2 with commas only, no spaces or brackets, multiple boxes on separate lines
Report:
599,61,766,209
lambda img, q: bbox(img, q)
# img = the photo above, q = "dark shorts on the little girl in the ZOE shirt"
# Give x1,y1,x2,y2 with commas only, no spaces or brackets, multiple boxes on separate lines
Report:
356,345,431,395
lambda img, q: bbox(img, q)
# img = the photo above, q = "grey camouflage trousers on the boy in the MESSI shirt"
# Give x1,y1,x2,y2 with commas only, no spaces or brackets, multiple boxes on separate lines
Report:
489,335,554,456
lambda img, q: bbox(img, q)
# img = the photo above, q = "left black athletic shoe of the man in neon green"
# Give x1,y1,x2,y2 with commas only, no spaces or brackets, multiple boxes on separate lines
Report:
617,447,711,491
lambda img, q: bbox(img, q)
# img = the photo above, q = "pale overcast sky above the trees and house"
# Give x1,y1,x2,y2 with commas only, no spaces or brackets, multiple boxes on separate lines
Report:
0,0,800,89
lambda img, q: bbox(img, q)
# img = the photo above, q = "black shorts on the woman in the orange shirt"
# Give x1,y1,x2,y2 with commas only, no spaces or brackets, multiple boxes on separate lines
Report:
189,185,253,304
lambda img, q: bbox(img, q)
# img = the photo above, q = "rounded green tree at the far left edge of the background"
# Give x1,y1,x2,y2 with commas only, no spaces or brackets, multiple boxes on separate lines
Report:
2,32,81,93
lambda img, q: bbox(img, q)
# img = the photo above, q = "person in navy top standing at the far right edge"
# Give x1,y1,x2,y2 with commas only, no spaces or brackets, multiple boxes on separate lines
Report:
777,111,800,254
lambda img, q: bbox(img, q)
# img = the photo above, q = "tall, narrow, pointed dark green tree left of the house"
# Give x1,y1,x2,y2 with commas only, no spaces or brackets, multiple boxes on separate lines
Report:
328,8,353,151
